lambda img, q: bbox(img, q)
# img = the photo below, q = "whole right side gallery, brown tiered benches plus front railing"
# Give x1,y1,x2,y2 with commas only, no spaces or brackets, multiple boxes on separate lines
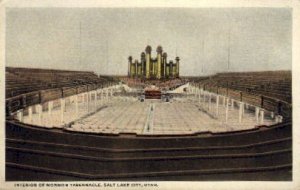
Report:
187,71,292,118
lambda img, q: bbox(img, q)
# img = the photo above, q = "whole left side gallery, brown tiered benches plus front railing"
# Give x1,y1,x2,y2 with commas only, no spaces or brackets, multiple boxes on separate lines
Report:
5,67,118,117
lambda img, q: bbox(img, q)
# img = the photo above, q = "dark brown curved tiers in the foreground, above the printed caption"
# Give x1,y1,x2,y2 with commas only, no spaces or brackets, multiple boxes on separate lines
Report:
6,119,292,181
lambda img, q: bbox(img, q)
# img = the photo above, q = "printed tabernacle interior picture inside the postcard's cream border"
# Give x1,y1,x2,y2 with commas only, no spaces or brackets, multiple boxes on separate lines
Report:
5,7,293,181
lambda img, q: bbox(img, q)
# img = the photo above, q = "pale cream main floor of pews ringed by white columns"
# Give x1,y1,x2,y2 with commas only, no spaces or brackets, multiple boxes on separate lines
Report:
14,81,282,135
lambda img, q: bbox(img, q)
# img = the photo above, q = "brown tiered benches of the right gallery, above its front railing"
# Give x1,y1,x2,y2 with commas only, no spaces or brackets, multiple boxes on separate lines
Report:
190,71,292,103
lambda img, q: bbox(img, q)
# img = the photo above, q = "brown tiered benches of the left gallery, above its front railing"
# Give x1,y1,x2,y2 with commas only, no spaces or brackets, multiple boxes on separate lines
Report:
5,67,111,98
